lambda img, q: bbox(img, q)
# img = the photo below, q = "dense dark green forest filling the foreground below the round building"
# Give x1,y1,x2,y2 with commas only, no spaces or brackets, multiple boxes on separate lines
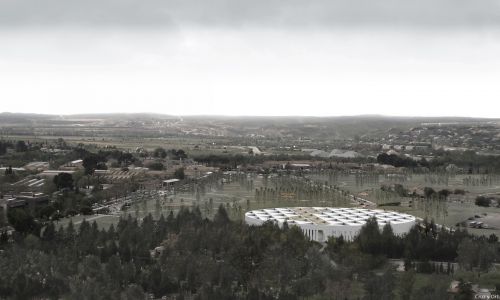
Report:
0,207,500,299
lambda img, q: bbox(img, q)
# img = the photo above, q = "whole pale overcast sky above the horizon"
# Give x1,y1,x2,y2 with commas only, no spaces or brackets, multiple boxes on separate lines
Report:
0,0,500,117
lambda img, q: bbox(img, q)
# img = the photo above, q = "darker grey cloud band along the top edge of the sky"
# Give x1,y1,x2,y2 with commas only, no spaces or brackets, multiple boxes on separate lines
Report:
0,0,500,27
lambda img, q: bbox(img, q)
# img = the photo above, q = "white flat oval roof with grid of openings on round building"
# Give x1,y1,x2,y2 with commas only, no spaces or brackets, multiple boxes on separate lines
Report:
245,207,416,226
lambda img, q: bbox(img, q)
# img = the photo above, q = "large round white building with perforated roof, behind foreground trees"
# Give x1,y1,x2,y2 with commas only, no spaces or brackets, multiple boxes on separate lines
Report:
245,207,416,242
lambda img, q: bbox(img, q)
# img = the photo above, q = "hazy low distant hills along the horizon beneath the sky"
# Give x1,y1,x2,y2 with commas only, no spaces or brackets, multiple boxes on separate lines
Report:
0,113,500,140
